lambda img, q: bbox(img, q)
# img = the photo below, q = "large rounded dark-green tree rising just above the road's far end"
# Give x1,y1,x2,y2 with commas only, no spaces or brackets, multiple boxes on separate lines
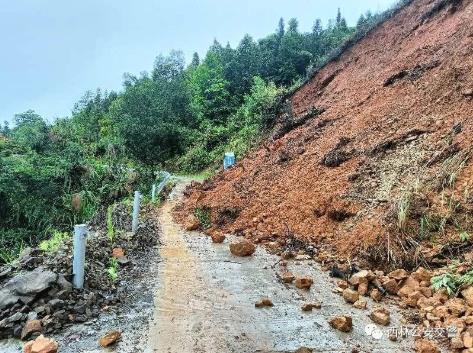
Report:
111,52,193,165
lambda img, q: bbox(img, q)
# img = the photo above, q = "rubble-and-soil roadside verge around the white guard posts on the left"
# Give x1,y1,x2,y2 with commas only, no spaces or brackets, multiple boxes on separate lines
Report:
0,204,159,339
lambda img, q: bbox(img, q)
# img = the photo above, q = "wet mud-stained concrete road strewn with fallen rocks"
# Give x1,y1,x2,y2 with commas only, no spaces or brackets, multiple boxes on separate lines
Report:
146,183,410,353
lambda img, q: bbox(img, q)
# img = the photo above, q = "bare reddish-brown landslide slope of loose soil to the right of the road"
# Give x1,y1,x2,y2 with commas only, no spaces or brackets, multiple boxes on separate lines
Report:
176,0,473,267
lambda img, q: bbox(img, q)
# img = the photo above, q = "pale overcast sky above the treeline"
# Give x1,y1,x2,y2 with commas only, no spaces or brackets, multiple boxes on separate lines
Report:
0,0,395,121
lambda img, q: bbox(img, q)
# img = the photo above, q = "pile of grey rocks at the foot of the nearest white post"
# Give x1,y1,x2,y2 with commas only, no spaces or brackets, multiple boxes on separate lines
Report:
0,268,107,340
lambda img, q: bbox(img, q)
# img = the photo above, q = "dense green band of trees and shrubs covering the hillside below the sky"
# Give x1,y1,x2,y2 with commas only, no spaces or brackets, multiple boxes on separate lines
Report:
0,8,384,261
